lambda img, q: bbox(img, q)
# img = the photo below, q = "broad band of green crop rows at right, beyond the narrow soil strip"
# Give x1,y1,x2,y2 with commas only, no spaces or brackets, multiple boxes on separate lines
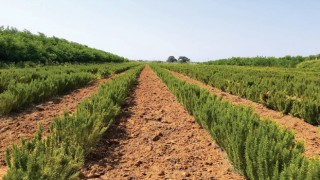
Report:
163,65,320,125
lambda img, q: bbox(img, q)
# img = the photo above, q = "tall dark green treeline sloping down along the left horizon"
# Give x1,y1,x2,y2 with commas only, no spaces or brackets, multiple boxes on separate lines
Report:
0,27,127,64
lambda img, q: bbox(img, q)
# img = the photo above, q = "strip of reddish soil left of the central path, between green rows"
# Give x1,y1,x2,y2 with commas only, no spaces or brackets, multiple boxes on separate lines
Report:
0,75,121,172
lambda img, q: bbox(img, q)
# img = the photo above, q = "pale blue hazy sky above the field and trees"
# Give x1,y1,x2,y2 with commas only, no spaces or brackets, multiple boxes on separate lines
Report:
0,0,320,62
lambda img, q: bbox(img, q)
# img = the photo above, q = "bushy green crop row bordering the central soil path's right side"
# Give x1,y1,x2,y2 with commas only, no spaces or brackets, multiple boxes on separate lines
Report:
152,65,320,180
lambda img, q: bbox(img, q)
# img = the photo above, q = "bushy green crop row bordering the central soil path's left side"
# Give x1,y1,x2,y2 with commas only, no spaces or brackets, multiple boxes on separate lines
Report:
4,66,142,180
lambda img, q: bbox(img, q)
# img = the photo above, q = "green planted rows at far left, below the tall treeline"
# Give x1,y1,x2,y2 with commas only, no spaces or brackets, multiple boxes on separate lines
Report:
0,63,137,115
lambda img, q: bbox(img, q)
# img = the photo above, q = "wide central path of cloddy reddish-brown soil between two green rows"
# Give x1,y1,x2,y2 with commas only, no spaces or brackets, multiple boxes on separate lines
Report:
82,66,244,179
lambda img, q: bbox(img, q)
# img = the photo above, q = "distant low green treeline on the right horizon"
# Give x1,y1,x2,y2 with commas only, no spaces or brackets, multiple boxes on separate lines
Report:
205,54,320,68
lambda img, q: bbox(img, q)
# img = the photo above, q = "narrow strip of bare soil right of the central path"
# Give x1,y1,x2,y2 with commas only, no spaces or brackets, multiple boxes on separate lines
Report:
170,71,320,158
